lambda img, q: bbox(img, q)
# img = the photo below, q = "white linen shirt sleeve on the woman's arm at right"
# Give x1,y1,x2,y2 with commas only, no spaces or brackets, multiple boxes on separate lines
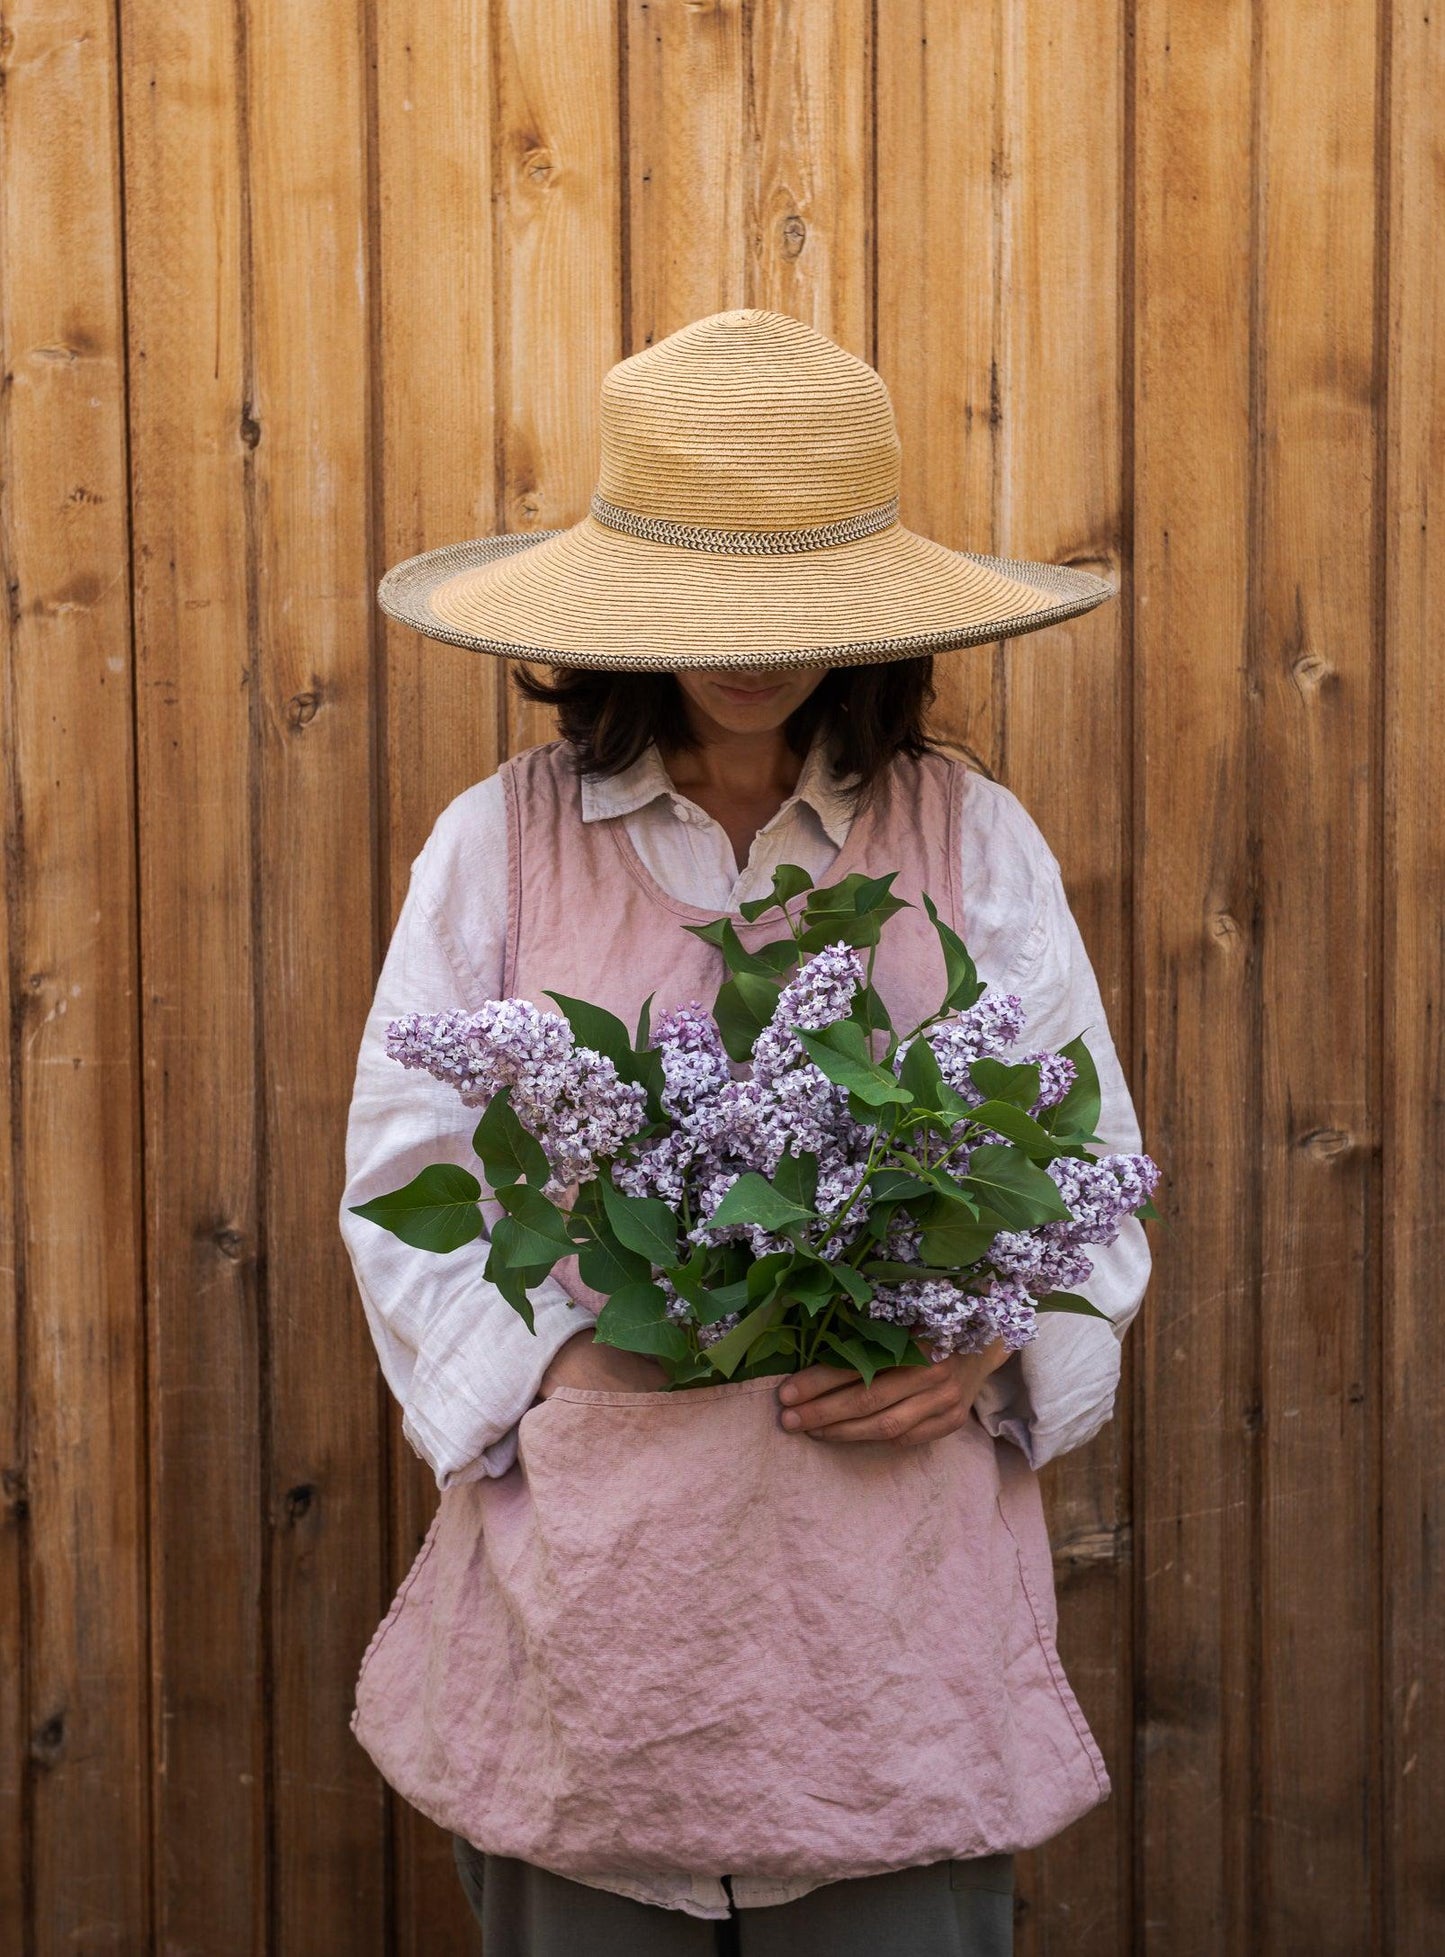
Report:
975,832,1151,1468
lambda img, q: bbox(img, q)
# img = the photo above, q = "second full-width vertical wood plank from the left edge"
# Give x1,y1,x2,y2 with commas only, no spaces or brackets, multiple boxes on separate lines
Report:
123,0,270,1957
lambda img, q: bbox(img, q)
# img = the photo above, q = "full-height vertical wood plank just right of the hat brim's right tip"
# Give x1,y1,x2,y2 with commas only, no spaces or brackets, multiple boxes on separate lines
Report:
1130,0,1259,1951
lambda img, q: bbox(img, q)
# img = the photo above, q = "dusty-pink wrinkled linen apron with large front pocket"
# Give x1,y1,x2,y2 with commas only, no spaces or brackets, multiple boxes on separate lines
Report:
352,742,1110,1881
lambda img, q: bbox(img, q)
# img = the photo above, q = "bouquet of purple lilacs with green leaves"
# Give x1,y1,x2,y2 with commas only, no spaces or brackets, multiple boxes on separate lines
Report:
352,863,1159,1388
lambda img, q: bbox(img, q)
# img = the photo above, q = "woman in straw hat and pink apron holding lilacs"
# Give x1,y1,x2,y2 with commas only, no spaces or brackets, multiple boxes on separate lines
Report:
341,309,1147,1957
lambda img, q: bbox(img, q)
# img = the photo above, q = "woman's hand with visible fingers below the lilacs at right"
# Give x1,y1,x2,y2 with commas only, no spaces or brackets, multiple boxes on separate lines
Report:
777,1339,1008,1448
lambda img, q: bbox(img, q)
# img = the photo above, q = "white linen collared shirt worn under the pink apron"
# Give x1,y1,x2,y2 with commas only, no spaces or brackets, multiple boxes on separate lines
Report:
341,742,1149,1916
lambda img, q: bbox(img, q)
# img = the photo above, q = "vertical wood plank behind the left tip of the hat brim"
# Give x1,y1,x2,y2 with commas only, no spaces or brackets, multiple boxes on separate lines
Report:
372,0,501,1957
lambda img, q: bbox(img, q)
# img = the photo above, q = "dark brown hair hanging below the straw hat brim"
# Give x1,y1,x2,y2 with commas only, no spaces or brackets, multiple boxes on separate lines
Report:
513,654,934,806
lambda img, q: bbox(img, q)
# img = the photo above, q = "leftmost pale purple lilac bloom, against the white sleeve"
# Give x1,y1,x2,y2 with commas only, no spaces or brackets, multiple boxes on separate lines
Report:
386,998,646,1198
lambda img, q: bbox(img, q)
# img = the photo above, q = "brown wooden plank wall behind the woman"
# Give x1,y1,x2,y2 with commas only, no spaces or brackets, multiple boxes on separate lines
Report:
0,0,1445,1957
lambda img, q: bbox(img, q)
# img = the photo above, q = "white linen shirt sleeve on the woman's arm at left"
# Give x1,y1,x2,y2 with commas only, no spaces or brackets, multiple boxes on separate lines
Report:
341,785,591,1489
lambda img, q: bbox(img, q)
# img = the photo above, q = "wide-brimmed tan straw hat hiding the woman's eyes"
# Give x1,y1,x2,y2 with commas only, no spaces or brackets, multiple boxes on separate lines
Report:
378,307,1116,671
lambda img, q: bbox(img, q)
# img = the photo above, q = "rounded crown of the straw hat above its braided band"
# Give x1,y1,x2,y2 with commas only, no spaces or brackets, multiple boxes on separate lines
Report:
597,307,901,530
